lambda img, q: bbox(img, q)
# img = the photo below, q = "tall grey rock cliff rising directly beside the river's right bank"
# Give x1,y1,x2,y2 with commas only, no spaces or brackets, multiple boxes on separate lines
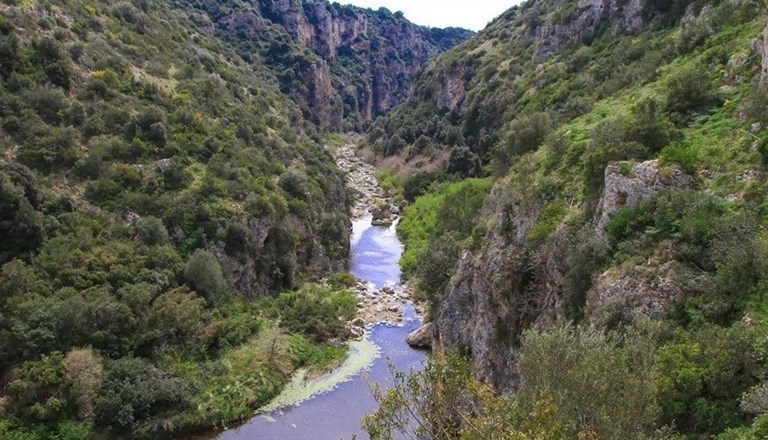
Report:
434,185,543,389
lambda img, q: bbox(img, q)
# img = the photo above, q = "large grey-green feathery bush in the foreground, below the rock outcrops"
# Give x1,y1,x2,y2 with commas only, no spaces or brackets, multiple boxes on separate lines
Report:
515,323,659,439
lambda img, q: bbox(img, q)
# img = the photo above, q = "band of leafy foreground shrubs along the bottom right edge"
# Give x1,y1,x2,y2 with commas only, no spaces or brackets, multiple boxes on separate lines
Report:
364,319,768,440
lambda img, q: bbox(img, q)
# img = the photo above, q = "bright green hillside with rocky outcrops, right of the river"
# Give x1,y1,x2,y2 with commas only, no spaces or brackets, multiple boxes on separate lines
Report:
368,0,768,438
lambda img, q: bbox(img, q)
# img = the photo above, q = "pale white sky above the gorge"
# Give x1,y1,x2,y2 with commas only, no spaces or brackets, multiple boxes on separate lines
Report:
336,0,521,31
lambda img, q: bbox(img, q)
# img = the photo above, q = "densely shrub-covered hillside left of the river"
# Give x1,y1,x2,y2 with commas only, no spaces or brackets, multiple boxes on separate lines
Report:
0,0,354,439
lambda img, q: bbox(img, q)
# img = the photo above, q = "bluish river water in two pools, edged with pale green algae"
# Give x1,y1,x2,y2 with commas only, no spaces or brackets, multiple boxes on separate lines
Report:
201,217,426,440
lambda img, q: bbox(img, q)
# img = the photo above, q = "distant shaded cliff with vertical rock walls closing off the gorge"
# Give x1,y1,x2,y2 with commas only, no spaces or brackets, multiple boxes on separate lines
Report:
178,0,472,130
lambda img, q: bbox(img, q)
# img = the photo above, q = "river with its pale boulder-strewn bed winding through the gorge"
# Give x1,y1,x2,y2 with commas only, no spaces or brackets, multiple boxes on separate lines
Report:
180,139,427,440
